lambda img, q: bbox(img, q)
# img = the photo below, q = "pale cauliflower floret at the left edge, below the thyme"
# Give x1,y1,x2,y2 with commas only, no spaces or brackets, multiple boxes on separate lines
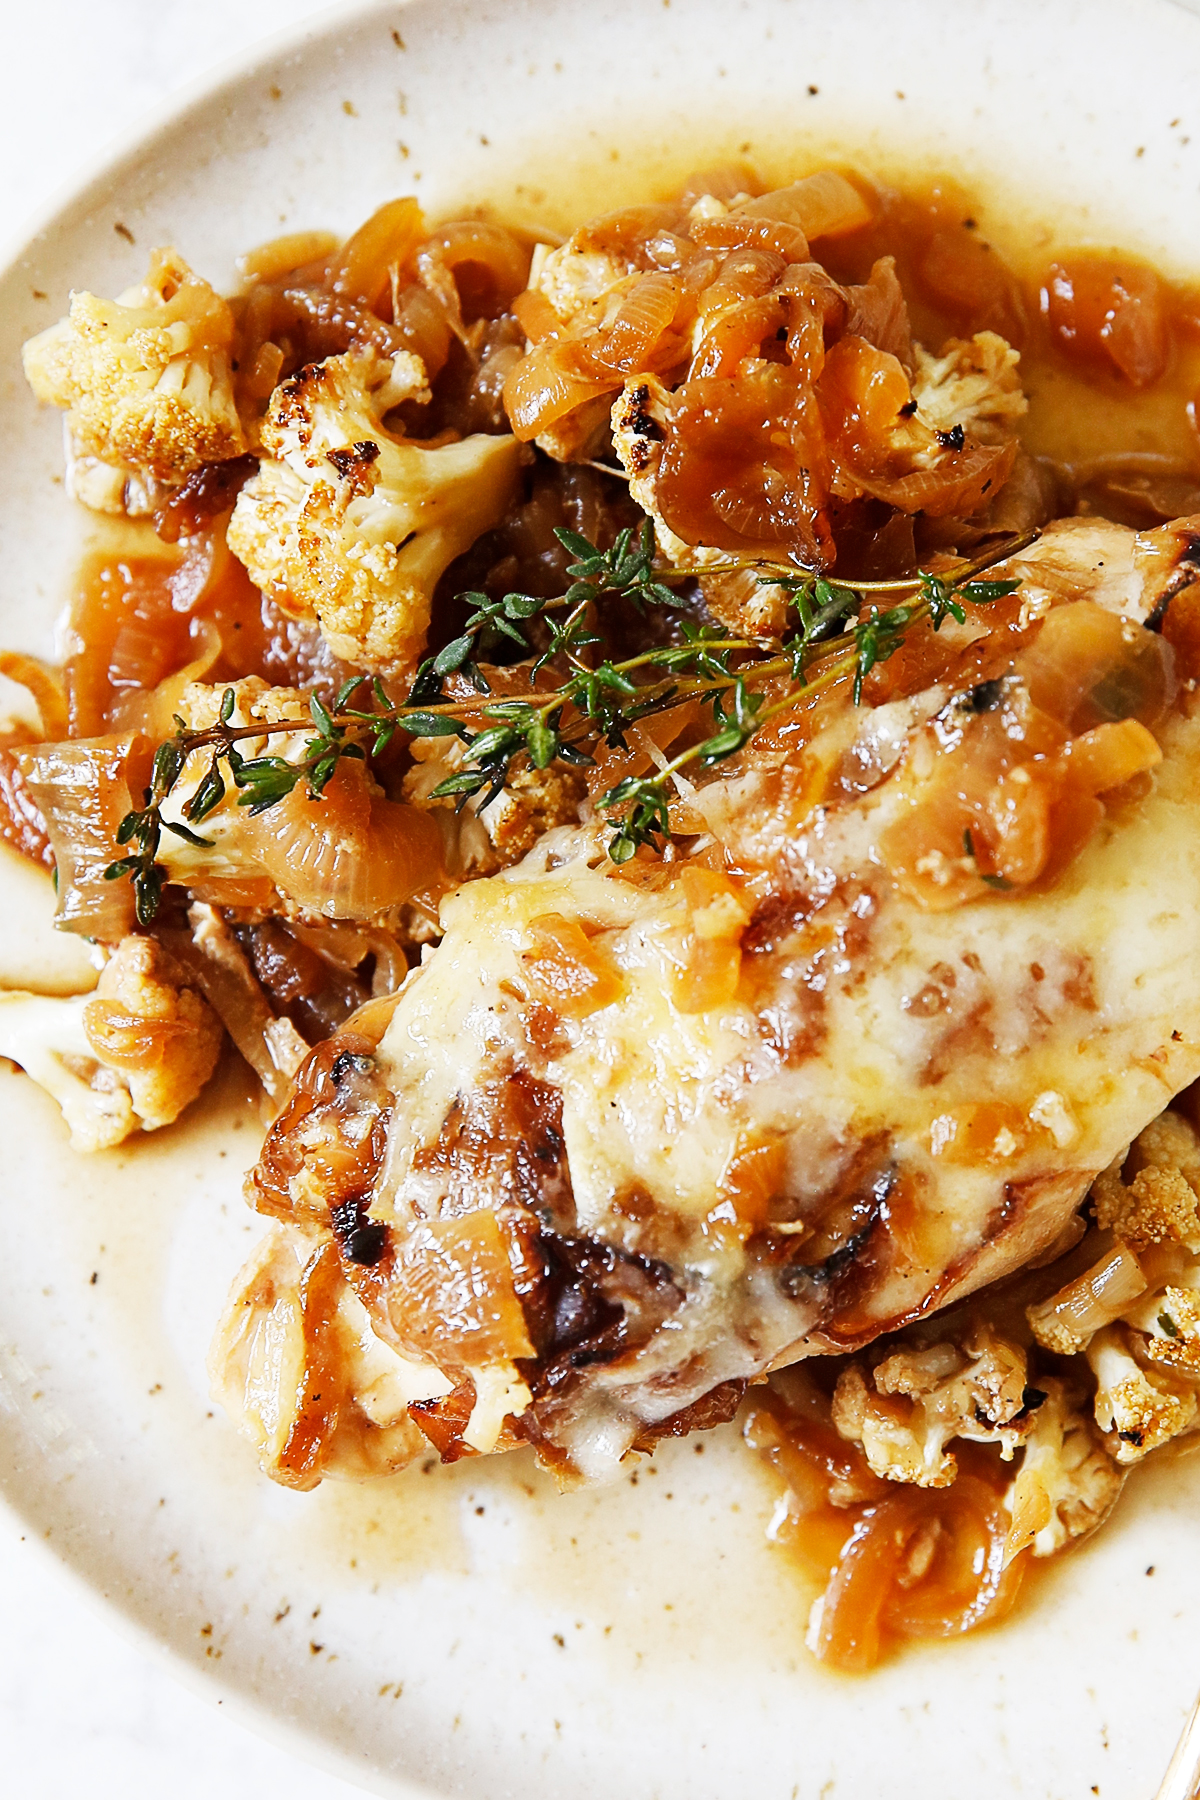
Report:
0,938,221,1150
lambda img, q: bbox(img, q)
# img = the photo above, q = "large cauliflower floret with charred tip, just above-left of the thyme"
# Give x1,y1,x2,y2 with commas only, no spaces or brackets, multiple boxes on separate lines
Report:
228,349,522,670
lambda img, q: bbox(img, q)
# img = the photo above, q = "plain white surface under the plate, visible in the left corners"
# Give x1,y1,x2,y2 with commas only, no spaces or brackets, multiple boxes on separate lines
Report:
0,0,376,1800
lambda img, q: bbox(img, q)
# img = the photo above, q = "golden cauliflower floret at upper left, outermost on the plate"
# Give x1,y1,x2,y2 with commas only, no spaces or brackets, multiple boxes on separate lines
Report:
23,250,246,511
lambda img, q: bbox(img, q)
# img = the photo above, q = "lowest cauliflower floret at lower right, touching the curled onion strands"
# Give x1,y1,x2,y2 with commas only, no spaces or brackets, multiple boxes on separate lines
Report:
1006,1375,1124,1559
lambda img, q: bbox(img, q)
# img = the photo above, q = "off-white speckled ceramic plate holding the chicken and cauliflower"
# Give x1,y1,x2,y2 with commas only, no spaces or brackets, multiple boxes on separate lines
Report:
0,0,1200,1800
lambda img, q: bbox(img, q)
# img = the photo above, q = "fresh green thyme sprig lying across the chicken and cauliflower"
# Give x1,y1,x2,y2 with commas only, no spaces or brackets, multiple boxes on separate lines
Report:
104,520,1029,925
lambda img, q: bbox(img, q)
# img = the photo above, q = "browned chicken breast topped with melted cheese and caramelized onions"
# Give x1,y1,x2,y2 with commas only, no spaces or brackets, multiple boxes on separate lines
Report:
216,520,1200,1485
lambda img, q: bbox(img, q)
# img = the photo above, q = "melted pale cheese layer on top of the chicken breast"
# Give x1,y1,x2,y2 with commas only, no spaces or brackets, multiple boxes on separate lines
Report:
380,702,1200,1375
